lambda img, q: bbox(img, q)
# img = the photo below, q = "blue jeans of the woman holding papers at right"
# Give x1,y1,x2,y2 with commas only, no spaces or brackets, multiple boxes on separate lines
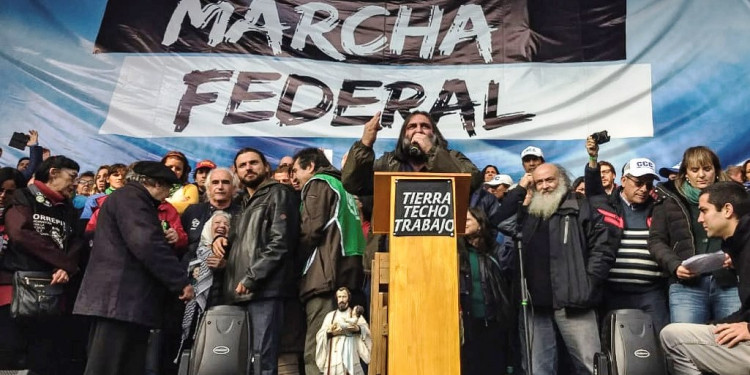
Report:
669,275,740,324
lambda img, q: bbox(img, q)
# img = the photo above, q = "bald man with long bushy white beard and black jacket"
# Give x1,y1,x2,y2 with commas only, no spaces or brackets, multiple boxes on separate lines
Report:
518,164,616,375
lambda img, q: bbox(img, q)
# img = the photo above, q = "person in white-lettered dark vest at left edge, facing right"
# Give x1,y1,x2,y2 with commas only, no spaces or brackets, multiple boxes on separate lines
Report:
0,156,85,375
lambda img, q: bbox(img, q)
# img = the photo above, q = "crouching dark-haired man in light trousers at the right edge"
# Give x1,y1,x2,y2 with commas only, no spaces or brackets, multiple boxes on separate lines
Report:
661,182,750,375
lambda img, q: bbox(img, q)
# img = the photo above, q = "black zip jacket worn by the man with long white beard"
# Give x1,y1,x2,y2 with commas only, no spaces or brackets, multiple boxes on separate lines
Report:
518,194,617,309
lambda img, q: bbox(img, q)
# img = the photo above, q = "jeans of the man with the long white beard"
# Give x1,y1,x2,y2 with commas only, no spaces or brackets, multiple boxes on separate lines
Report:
521,308,601,375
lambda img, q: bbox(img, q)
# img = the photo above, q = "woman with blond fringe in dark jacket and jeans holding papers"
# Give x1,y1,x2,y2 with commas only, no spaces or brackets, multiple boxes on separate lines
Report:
648,146,740,324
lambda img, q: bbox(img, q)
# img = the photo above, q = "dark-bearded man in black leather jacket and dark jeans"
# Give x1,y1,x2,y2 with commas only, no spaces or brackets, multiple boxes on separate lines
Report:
213,147,299,375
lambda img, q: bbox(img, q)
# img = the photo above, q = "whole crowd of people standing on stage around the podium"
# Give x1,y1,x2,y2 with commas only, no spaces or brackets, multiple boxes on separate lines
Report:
0,111,750,375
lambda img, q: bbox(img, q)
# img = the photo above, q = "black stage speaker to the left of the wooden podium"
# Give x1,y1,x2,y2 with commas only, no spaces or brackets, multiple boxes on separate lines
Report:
179,306,258,375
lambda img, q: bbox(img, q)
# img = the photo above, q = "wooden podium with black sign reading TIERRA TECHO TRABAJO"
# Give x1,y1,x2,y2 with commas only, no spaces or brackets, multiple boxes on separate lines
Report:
369,172,471,375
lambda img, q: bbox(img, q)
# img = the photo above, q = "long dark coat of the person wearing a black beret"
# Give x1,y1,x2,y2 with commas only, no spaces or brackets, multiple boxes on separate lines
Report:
73,182,190,327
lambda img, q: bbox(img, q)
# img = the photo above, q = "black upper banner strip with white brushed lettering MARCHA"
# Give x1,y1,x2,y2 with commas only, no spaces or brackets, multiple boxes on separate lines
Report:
95,0,626,65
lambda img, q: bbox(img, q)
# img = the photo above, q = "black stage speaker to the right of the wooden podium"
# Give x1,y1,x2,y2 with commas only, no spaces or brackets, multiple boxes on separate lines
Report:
594,309,667,375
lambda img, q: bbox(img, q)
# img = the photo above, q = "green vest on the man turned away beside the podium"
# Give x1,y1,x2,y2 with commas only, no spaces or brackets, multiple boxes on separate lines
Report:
300,173,366,256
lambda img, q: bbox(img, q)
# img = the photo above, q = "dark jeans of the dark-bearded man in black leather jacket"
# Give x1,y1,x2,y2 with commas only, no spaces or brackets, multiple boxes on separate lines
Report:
247,298,284,375
